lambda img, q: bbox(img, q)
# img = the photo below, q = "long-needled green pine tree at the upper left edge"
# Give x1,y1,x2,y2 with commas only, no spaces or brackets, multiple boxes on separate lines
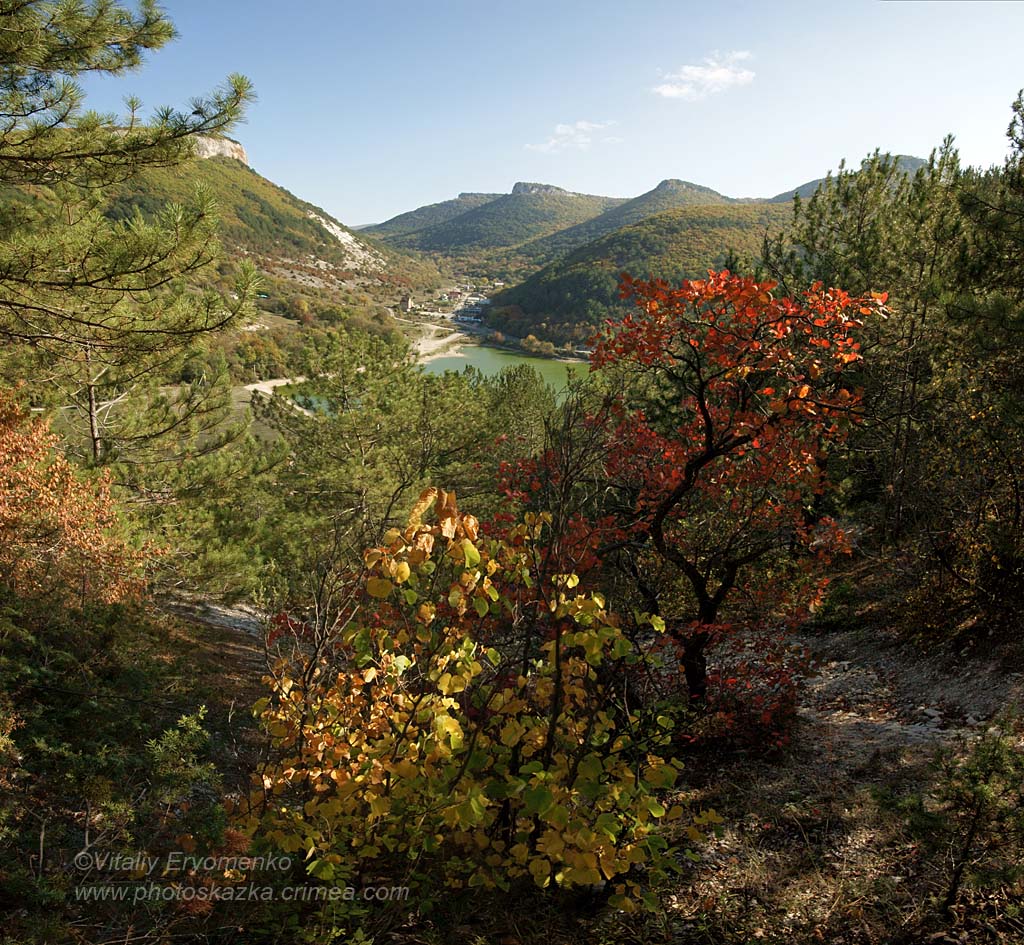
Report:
0,0,260,465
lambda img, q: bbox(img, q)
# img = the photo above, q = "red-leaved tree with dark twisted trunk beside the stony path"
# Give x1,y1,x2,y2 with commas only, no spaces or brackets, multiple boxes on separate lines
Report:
507,271,885,700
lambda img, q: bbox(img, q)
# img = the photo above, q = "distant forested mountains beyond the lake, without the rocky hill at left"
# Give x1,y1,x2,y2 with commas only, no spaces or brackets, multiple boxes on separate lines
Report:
360,156,926,344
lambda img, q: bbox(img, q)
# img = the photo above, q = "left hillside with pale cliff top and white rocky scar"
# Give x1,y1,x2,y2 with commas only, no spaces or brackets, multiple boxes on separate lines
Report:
105,149,441,383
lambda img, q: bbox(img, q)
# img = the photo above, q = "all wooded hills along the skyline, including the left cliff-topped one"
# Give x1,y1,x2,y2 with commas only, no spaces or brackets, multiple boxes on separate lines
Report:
101,142,925,352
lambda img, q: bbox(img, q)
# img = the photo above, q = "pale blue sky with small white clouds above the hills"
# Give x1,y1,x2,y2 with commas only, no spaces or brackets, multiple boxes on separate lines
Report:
86,0,1024,224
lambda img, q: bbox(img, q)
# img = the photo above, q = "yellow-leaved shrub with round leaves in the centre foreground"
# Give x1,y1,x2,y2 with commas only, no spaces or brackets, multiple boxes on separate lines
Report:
252,489,716,908
